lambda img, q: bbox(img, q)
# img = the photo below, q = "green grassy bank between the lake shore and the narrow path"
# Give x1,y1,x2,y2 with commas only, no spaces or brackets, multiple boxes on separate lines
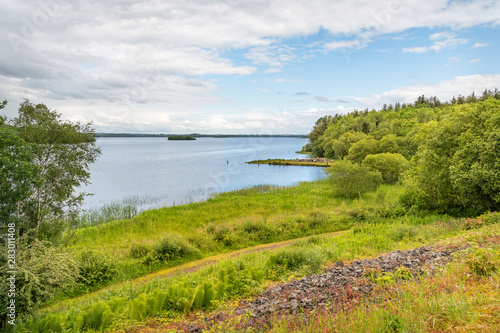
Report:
63,181,405,288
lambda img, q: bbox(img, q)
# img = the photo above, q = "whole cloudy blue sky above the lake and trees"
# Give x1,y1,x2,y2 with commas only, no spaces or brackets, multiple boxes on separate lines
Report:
0,0,500,134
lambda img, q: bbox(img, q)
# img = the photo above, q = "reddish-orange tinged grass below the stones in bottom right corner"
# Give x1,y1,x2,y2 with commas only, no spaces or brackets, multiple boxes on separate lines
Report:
264,237,500,333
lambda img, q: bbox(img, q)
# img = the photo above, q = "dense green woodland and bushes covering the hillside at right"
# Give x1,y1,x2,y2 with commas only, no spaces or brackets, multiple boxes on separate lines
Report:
303,89,500,215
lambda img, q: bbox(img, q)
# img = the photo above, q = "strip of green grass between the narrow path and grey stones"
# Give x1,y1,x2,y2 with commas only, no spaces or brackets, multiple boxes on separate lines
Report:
23,210,476,328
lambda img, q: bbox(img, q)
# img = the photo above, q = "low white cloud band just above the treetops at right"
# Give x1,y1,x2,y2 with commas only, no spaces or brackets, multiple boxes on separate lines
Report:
353,74,500,108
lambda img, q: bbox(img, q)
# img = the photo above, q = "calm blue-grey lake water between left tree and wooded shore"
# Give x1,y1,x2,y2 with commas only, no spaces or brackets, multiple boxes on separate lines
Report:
82,138,324,209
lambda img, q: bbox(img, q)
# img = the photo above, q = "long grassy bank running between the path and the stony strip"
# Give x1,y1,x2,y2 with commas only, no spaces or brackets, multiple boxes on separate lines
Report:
27,211,500,332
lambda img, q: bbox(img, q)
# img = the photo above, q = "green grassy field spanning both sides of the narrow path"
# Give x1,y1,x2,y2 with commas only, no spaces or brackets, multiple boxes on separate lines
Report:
19,180,500,332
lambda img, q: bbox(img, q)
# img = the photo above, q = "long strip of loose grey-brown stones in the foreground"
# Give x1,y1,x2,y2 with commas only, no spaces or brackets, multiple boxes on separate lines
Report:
195,246,457,326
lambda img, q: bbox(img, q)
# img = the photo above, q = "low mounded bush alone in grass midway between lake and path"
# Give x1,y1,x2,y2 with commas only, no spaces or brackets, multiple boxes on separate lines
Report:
144,234,201,264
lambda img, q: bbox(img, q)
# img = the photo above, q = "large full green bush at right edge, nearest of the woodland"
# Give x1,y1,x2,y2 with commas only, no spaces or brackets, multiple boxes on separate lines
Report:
405,99,500,213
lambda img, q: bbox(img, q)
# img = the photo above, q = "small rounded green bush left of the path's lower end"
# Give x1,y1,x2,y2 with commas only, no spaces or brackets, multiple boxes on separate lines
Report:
79,250,116,287
